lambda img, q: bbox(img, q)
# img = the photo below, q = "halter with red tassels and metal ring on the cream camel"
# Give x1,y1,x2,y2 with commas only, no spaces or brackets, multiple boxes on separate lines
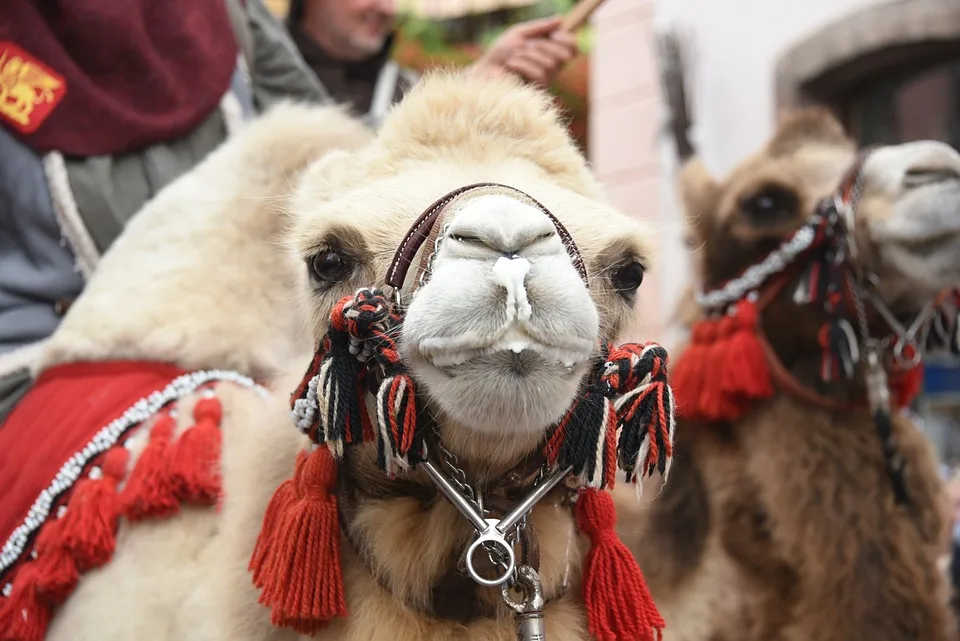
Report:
250,183,674,641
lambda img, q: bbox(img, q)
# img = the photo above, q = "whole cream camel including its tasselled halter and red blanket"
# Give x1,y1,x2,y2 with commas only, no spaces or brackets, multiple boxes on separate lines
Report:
0,75,673,641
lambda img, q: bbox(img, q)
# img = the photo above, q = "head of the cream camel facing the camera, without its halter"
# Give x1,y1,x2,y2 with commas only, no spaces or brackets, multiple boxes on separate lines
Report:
284,70,651,469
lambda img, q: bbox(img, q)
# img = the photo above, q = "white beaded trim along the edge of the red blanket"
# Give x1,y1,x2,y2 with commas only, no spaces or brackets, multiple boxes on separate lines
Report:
0,369,268,574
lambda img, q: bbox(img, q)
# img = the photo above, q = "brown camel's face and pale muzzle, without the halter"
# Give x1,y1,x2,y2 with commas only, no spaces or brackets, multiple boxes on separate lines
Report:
680,109,960,316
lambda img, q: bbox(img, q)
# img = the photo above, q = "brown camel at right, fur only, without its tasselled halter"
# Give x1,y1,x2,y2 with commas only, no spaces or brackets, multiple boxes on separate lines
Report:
621,110,960,641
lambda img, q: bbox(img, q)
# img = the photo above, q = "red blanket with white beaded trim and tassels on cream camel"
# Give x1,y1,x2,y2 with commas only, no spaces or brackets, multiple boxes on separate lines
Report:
0,361,236,641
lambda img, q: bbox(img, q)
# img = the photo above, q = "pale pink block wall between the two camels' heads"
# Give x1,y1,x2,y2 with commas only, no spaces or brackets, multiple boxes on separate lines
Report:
590,0,666,340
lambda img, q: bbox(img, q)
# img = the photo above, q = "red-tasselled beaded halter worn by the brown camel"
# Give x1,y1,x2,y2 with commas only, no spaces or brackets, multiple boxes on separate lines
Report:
673,150,960,503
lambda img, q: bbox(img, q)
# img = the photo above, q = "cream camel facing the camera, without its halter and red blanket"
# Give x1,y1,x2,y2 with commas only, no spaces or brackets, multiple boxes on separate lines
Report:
1,70,668,641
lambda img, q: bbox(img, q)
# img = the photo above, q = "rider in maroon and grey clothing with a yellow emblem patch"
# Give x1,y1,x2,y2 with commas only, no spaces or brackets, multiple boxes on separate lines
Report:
0,0,330,418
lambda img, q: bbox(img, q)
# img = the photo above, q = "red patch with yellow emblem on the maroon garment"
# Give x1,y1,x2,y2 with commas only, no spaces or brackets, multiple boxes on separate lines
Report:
0,42,67,134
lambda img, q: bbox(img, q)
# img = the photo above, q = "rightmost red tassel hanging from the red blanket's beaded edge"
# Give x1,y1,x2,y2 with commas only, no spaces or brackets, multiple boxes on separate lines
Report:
170,396,223,505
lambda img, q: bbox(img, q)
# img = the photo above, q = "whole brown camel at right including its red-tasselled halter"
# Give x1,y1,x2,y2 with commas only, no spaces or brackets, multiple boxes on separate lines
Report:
621,35,960,641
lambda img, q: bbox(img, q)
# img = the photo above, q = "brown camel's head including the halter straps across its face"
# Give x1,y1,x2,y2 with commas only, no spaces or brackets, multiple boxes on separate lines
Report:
678,109,960,415
